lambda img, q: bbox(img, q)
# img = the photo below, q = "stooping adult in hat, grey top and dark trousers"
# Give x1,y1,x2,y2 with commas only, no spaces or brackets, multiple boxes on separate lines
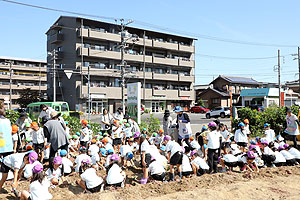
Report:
44,111,69,163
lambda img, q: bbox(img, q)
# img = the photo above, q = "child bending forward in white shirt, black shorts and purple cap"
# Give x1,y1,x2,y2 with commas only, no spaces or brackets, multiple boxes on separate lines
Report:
163,135,183,181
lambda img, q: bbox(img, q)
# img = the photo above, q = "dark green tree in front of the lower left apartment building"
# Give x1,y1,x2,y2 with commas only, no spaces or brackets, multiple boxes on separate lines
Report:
16,88,40,108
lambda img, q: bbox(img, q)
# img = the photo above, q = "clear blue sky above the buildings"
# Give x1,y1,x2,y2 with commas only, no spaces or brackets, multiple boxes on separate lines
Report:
0,0,300,84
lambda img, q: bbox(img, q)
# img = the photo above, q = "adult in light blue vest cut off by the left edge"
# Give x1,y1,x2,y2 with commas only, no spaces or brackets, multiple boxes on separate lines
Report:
0,101,13,159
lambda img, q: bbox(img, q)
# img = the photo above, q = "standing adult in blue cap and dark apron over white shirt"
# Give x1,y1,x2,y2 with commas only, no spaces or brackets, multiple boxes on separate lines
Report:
174,106,192,149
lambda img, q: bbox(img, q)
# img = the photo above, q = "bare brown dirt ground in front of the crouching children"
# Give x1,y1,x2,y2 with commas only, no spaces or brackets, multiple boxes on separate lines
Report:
0,166,300,200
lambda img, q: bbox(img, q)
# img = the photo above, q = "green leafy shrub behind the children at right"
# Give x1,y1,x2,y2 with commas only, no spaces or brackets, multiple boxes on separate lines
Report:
233,106,299,136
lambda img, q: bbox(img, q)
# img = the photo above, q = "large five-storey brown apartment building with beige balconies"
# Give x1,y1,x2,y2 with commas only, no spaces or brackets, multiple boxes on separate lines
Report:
46,16,195,113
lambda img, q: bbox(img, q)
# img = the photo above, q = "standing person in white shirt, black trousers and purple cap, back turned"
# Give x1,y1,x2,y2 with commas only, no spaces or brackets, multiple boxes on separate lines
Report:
207,122,222,173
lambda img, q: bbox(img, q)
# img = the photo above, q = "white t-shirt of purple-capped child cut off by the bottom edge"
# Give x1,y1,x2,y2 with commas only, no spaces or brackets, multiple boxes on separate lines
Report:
29,178,52,200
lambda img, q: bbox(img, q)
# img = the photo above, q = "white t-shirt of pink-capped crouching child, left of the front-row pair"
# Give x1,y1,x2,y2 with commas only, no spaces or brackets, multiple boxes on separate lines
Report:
80,168,103,189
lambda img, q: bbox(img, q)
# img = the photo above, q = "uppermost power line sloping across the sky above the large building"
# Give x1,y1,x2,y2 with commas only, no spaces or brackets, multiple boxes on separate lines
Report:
0,0,298,47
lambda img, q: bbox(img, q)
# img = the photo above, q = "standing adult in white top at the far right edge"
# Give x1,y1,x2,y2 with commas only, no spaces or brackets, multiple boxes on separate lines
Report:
284,108,299,148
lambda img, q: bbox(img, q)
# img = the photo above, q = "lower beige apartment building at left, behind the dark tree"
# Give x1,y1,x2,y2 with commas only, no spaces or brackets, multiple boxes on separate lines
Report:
0,56,47,109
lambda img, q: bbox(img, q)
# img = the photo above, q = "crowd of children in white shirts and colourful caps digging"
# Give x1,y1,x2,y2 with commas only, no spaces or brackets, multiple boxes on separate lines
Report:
0,112,300,200
